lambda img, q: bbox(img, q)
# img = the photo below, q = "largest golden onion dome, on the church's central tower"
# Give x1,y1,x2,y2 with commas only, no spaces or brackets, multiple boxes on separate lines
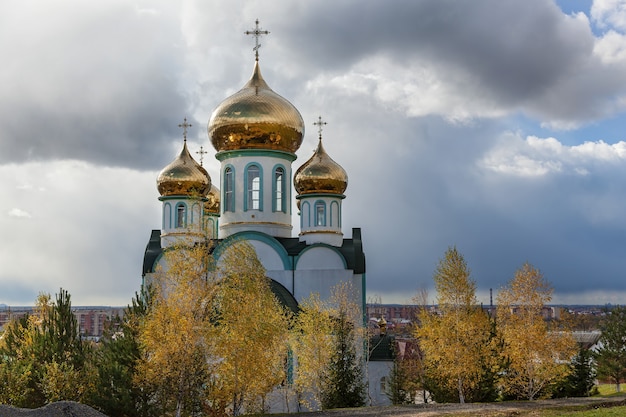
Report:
208,61,304,153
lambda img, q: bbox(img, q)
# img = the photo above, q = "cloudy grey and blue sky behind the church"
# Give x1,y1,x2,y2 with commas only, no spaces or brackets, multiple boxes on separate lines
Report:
0,0,626,305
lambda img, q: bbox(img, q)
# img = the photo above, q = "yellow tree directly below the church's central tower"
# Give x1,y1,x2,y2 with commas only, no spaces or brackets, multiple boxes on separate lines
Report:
207,242,289,415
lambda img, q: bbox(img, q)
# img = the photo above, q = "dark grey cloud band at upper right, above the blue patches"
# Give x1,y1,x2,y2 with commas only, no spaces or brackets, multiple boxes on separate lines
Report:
272,0,626,126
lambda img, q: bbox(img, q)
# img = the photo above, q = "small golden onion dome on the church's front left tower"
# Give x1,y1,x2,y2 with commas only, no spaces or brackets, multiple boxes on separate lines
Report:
157,141,211,197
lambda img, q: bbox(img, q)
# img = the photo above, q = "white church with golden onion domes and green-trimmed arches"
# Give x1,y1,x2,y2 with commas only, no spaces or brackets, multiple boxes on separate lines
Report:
142,21,365,311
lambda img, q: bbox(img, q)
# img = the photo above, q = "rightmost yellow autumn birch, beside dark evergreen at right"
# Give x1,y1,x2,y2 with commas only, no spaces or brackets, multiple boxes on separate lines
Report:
497,263,576,400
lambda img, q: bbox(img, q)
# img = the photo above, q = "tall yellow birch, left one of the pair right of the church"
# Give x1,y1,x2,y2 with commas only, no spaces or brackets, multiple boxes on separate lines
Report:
415,247,497,403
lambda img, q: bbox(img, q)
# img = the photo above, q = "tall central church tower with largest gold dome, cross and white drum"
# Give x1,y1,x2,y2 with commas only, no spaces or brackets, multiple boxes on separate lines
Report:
208,20,304,239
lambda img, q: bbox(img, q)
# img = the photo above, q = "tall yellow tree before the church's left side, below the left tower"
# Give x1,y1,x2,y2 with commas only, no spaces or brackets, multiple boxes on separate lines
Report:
134,245,218,416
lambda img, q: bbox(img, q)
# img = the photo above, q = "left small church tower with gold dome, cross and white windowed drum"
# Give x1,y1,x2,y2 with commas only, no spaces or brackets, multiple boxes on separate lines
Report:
157,119,211,248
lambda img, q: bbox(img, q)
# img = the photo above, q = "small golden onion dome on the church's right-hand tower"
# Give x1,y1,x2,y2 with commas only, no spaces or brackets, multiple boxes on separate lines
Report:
293,138,348,194
